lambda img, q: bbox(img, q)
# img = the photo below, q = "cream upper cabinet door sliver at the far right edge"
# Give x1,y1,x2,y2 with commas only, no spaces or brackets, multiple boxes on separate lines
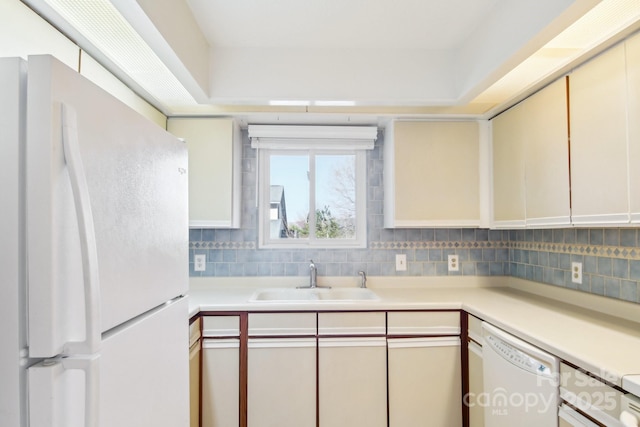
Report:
625,34,640,224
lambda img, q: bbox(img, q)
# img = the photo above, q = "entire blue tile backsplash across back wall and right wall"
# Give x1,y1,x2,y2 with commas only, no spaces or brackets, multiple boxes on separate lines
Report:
189,132,640,303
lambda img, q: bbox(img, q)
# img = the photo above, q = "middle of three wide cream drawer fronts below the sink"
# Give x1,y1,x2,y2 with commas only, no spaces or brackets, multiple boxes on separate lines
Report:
318,312,386,335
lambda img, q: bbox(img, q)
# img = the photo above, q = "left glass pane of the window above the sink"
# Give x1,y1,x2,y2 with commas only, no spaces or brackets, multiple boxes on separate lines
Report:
269,155,309,239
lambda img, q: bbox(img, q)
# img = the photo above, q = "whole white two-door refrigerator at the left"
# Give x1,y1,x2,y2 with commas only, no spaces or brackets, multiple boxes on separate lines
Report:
0,55,189,427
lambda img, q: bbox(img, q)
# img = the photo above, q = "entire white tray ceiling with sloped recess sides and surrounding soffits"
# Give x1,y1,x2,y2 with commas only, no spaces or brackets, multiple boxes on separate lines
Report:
22,0,640,123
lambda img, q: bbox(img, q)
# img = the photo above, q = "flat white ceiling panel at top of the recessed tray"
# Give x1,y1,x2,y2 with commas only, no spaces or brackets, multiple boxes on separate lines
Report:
187,0,498,49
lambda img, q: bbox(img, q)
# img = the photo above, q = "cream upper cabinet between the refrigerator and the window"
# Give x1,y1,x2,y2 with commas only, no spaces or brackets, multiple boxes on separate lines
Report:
167,118,242,228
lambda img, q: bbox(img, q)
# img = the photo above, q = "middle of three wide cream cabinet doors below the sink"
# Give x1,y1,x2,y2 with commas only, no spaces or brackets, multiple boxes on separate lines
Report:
318,338,388,427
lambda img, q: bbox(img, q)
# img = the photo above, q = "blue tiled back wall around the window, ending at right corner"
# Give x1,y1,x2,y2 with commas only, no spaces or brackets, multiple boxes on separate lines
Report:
189,132,509,277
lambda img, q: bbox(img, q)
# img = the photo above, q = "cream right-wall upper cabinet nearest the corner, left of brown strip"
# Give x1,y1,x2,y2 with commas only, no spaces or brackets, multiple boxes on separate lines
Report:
492,79,570,228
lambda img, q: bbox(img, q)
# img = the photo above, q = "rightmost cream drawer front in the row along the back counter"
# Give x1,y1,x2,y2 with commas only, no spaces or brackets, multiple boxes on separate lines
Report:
387,311,460,335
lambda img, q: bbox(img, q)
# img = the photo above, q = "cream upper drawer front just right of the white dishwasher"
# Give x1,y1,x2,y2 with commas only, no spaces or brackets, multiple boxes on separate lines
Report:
560,363,623,425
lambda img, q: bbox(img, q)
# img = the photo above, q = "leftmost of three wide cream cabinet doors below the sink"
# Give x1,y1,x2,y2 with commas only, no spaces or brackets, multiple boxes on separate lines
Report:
247,338,316,427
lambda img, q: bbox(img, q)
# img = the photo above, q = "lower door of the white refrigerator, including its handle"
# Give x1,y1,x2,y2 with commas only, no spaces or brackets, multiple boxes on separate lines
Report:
28,297,189,427
